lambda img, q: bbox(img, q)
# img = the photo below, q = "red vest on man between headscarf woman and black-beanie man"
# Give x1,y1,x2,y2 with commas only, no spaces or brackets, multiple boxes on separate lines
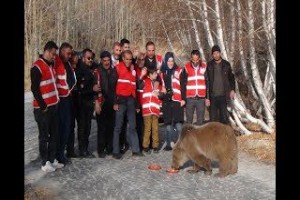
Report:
185,62,206,98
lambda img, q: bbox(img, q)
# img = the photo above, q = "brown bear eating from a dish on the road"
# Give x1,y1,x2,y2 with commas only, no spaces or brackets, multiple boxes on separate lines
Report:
172,122,238,177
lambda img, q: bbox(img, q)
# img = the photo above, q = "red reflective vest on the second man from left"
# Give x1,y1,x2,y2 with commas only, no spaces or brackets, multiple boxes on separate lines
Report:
54,55,75,97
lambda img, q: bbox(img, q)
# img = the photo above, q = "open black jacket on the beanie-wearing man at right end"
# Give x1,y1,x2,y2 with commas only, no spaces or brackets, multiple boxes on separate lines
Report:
205,59,235,100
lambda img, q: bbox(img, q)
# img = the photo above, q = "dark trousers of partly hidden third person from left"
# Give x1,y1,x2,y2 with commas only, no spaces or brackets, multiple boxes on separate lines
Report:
67,94,79,155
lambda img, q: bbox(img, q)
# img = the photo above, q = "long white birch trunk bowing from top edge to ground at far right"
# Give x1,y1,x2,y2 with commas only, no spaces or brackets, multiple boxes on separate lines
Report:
248,0,275,127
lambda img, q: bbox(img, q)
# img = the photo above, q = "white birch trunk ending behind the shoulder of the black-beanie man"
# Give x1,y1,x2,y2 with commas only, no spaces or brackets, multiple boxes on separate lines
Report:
214,0,228,60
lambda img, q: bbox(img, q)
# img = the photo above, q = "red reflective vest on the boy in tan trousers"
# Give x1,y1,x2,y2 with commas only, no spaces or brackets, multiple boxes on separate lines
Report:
142,78,161,117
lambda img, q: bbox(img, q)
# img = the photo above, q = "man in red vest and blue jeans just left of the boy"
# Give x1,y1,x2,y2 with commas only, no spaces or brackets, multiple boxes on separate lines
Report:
113,50,143,159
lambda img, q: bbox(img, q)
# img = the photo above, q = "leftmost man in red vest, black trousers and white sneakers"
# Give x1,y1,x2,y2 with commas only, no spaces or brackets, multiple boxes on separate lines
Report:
30,41,62,172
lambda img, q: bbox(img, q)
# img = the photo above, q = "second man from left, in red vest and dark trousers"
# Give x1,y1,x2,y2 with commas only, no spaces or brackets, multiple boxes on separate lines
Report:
54,42,76,165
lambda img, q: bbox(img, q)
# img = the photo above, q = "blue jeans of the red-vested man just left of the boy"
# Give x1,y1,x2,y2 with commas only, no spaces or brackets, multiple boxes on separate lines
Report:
113,97,140,154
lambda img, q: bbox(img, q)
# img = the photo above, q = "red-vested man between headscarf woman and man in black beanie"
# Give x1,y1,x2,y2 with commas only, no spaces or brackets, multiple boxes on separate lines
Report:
184,50,207,125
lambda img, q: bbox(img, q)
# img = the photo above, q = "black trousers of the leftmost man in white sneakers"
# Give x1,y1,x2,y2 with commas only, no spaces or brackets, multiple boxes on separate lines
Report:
33,105,58,165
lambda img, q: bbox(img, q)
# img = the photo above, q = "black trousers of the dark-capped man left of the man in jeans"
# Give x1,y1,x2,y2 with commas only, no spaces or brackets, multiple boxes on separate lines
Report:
96,101,115,154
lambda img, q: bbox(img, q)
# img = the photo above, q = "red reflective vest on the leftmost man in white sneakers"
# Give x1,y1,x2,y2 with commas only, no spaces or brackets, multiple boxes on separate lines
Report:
32,58,59,108
